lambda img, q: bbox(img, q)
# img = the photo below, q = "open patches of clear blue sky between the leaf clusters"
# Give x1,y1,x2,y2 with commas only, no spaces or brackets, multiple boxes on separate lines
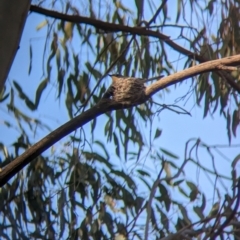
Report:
0,0,240,235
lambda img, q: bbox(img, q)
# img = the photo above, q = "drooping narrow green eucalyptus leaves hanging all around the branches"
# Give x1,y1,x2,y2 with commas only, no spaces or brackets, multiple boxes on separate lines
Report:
0,0,240,239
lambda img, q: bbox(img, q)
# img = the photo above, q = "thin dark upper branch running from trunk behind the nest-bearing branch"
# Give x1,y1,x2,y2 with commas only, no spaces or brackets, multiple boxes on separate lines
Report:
30,5,240,93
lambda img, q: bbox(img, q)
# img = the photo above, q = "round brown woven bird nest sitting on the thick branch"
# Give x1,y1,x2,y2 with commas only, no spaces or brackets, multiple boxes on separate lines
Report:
112,78,146,105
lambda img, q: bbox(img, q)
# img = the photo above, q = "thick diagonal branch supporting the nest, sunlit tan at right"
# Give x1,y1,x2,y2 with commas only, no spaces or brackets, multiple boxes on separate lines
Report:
0,54,240,187
